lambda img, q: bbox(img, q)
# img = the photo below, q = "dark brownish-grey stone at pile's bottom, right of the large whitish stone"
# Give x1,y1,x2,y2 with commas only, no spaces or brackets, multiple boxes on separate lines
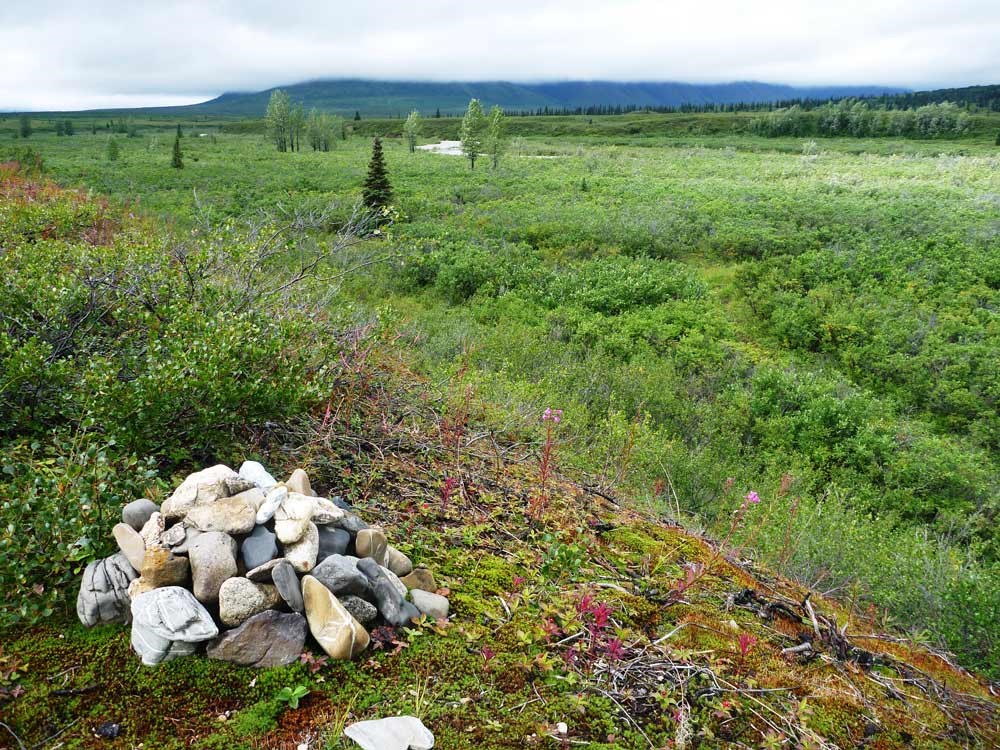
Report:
207,609,308,667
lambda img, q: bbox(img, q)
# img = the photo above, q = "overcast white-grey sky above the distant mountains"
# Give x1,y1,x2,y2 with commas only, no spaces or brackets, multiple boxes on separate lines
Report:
0,0,1000,110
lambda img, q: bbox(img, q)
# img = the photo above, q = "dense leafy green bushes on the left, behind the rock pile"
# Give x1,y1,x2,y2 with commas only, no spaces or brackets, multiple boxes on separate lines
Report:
0,172,360,624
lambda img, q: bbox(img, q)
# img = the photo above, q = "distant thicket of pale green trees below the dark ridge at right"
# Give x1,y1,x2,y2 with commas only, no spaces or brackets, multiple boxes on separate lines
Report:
748,99,972,138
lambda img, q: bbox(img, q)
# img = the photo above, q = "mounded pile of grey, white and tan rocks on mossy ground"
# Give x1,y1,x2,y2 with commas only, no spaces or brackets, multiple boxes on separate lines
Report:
77,461,448,667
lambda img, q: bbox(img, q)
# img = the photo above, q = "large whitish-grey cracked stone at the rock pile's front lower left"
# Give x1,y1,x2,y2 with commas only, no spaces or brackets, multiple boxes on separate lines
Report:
131,586,219,666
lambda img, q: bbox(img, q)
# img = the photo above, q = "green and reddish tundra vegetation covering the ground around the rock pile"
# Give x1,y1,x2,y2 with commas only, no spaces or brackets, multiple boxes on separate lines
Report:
0,107,1000,748
